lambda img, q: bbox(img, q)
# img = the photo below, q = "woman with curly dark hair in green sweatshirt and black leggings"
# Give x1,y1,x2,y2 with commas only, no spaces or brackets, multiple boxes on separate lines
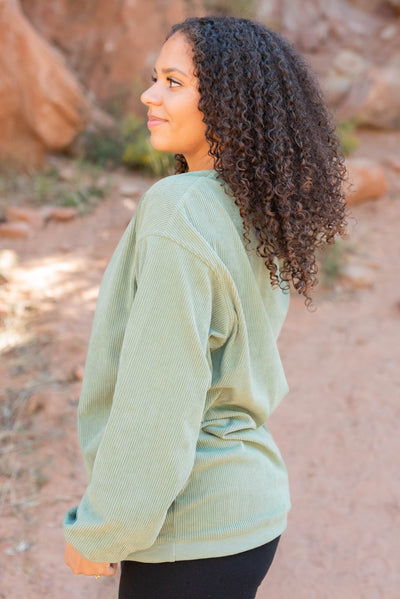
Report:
64,17,344,599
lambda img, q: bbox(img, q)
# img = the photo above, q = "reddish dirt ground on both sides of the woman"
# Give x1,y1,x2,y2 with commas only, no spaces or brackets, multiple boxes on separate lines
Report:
0,134,400,599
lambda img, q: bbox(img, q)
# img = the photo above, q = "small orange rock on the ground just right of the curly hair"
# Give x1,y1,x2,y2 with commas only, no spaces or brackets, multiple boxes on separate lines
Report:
347,158,388,205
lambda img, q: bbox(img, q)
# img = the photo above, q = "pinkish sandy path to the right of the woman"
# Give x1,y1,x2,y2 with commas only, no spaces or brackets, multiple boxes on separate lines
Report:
259,200,400,599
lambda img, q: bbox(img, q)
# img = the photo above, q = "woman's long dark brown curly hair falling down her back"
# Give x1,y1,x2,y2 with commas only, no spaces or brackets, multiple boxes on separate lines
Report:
167,16,346,305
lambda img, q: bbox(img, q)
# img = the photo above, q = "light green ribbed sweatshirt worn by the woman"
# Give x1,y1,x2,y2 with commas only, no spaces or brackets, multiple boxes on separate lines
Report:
64,170,290,562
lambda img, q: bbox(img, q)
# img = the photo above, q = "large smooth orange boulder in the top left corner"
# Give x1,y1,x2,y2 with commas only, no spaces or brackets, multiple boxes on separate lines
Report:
0,0,90,168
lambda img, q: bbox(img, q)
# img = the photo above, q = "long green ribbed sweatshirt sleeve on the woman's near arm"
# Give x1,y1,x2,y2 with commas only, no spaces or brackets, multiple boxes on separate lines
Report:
64,234,215,562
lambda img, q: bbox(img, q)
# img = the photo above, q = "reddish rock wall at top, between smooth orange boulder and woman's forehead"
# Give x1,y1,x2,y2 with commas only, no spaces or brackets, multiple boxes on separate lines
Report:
20,0,190,113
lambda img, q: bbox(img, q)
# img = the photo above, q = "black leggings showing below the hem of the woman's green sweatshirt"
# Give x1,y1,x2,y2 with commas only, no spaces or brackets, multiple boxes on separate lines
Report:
118,537,279,599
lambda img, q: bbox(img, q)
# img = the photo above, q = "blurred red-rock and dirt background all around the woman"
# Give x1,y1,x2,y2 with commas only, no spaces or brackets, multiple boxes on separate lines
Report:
0,0,400,599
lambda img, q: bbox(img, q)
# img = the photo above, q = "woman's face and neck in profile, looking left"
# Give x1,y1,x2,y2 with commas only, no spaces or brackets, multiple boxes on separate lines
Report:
140,33,213,171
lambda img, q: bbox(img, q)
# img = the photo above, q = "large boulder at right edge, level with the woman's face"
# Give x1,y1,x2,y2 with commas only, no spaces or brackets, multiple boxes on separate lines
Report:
338,60,400,130
